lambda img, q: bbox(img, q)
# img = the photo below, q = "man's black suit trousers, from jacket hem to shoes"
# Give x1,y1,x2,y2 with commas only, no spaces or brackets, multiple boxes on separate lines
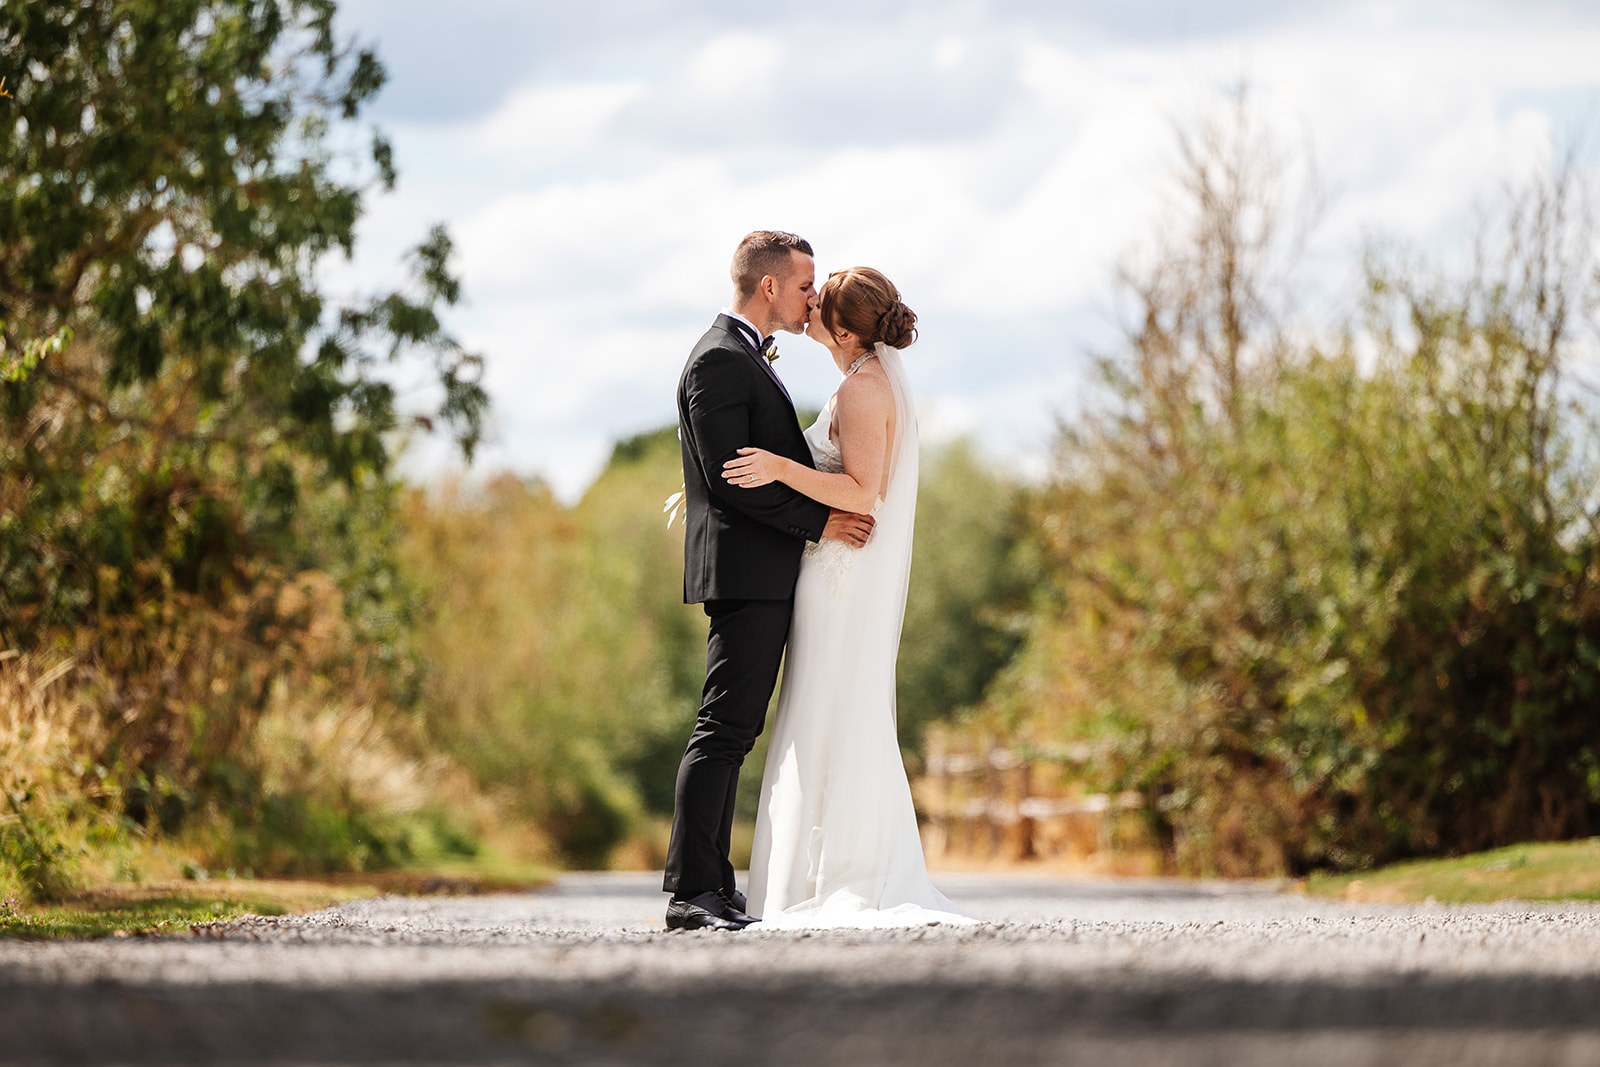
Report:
662,598,794,901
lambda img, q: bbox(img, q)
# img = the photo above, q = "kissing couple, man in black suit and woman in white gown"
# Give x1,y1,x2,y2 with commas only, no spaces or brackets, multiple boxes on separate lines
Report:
664,230,976,931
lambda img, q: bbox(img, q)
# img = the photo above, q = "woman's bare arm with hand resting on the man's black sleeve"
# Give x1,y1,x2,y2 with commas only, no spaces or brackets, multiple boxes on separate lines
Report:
722,374,894,515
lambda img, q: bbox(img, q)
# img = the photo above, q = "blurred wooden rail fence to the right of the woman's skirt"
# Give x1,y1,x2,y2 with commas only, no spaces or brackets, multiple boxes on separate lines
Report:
914,749,1146,861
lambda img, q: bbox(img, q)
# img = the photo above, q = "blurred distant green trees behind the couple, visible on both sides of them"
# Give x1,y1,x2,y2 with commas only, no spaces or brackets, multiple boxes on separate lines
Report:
406,427,1026,865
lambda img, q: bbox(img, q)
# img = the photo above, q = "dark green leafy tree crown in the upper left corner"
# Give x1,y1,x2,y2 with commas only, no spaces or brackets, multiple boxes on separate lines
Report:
0,0,485,463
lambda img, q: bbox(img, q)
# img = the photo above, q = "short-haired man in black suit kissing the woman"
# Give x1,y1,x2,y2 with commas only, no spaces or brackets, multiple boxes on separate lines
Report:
664,230,872,929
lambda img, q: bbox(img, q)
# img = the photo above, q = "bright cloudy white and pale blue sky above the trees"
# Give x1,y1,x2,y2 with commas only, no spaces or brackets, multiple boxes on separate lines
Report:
328,0,1600,499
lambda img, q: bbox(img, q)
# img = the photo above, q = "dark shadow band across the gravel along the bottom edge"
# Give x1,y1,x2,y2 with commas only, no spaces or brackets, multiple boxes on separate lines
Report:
9,976,1600,1065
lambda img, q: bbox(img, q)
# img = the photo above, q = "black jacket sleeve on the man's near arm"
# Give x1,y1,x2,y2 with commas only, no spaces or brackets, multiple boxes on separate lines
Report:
685,349,829,541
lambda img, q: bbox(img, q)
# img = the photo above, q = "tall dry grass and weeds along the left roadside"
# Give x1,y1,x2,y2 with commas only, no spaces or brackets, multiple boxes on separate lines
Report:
0,653,544,904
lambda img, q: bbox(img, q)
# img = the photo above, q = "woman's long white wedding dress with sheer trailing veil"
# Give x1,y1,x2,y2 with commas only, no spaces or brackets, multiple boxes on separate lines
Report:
747,344,978,929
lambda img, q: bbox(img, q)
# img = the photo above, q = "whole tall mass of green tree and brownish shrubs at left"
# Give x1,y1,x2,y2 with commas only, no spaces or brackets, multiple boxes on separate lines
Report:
0,0,486,873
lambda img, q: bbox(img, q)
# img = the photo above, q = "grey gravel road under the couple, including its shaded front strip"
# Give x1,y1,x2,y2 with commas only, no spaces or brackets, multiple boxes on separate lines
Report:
0,873,1600,1067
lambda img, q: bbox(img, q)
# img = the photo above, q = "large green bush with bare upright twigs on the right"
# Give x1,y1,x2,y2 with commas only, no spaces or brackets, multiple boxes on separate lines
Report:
989,106,1600,873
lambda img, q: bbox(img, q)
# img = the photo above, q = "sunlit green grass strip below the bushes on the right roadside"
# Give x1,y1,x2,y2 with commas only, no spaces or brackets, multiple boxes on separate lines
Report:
1306,838,1600,904
